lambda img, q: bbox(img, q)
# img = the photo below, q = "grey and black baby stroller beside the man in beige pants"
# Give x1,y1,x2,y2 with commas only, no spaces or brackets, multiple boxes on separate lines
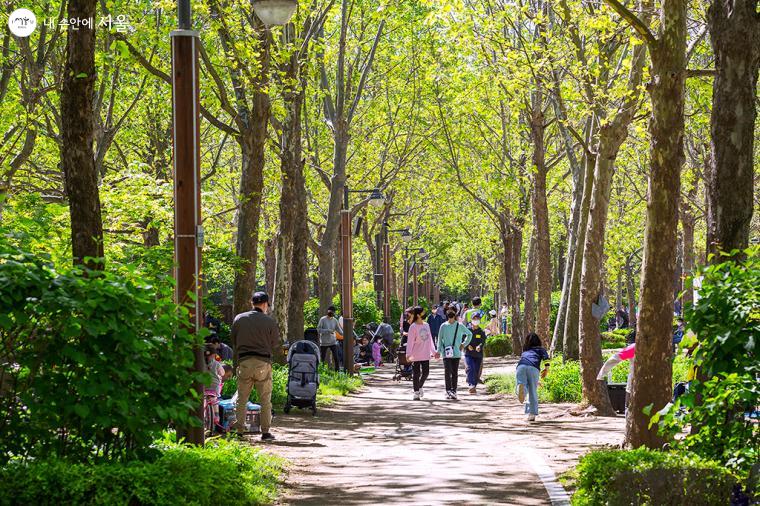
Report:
283,340,319,415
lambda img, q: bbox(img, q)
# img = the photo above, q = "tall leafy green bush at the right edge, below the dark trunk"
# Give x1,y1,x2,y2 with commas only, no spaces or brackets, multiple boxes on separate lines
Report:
652,247,760,474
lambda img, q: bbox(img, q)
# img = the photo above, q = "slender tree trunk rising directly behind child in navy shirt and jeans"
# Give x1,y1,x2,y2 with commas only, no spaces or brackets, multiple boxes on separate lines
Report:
530,93,552,347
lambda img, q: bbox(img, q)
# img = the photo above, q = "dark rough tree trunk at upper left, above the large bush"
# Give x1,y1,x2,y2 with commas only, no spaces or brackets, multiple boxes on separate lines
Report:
61,0,103,269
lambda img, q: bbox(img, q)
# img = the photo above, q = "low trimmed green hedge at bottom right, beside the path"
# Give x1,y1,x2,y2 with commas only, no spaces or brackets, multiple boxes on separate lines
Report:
572,448,735,506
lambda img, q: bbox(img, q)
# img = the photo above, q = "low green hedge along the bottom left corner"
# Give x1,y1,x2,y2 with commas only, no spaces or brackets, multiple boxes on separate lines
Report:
0,439,283,506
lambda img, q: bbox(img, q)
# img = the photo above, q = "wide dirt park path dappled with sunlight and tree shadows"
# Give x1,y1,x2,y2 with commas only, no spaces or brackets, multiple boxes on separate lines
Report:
265,359,624,506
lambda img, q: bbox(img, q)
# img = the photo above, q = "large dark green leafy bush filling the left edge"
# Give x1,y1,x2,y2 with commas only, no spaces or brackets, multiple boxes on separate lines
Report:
0,243,202,464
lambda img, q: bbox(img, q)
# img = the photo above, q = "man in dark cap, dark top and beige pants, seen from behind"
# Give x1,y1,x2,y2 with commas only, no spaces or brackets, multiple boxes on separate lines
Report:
230,292,280,441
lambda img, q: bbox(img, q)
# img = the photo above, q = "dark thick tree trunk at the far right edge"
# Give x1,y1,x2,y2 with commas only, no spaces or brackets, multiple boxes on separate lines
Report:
707,0,760,263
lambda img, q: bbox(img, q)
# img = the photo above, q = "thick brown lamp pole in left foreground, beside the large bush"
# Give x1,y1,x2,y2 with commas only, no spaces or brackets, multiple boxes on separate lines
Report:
171,17,206,445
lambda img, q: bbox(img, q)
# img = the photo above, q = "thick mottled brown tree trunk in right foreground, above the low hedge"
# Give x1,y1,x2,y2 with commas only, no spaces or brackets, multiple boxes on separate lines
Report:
626,0,687,448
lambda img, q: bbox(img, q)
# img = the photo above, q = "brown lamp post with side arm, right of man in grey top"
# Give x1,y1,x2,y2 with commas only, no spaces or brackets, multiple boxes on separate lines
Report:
340,184,385,374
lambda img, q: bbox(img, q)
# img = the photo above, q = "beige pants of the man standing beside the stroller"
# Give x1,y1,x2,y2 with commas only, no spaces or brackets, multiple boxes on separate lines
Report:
235,357,272,434
